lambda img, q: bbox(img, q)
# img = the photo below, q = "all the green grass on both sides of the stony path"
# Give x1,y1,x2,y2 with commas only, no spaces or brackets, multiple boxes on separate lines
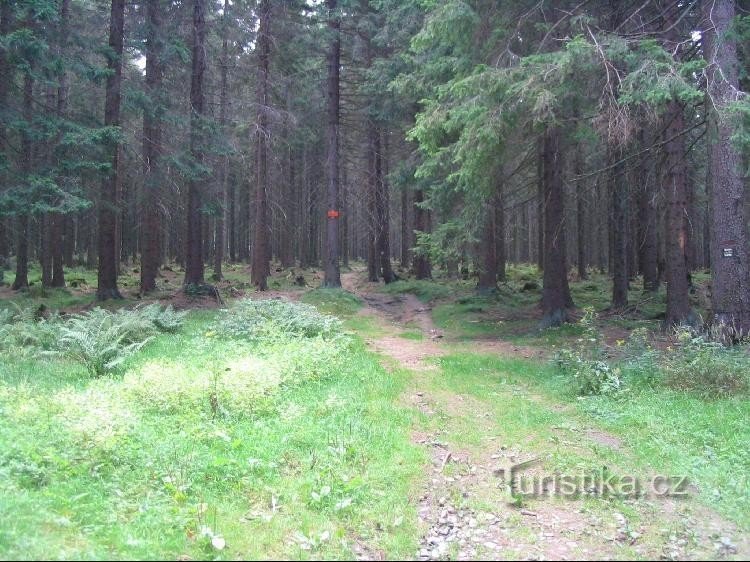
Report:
0,266,750,559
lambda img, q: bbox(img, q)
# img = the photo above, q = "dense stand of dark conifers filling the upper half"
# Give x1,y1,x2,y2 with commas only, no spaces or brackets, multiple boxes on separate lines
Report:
0,0,750,332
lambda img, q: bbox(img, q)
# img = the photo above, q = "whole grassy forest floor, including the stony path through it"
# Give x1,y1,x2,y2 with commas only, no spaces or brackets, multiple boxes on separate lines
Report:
0,260,750,560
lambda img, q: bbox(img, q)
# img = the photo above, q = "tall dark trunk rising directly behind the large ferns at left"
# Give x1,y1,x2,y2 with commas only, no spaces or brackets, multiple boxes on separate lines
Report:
96,0,125,300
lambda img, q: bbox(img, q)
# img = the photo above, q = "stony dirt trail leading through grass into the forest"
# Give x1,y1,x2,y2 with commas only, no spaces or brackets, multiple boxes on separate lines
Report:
342,271,750,560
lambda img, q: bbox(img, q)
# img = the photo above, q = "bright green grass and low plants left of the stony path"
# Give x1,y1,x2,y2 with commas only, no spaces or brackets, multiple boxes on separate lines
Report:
0,312,424,559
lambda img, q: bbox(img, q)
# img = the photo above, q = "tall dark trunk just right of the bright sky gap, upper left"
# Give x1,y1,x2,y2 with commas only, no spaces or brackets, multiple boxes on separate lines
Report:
140,0,164,293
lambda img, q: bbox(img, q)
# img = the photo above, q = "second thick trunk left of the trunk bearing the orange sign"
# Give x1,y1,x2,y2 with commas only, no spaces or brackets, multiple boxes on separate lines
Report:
185,0,206,285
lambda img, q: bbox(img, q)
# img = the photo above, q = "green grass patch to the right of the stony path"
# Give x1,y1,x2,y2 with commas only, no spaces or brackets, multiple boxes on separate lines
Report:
440,353,750,529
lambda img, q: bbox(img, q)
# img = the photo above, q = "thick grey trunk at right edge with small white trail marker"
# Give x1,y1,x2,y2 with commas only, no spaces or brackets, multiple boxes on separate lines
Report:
703,0,750,337
